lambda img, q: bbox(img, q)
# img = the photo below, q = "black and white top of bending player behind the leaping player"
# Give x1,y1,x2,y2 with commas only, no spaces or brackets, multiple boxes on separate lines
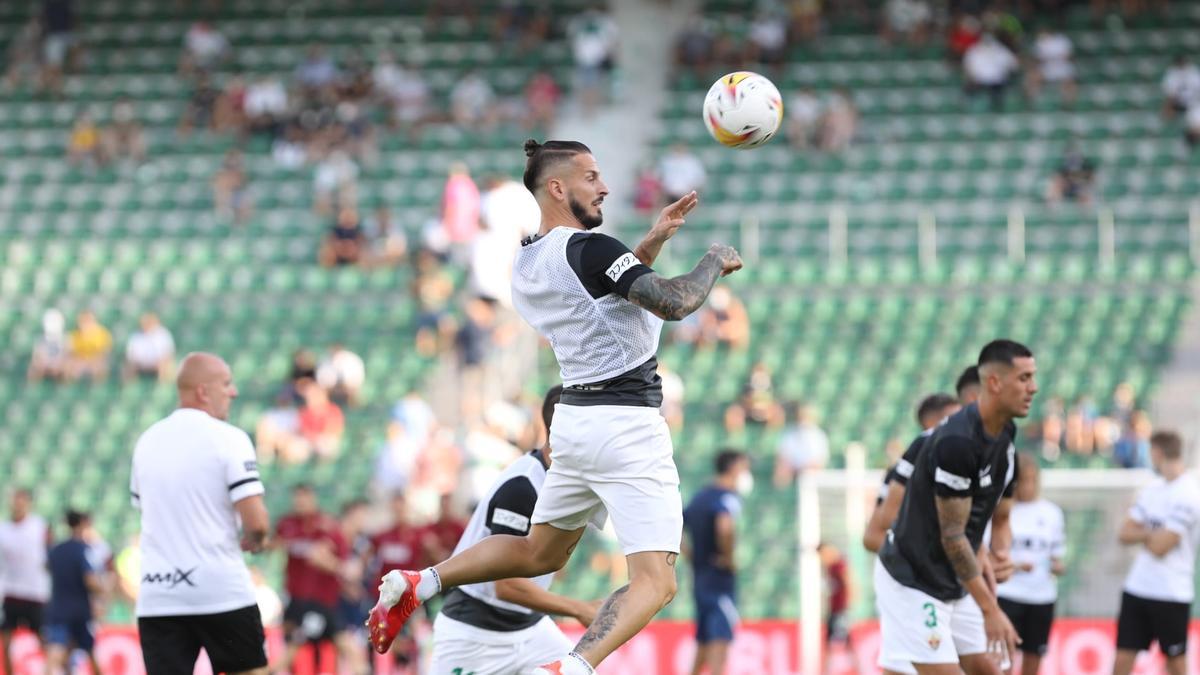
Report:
442,450,554,632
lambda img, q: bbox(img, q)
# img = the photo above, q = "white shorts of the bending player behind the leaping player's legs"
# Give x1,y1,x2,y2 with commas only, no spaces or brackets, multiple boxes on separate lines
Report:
430,614,575,675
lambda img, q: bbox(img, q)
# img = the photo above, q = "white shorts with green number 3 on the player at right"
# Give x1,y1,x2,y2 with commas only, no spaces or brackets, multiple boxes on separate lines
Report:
875,563,988,673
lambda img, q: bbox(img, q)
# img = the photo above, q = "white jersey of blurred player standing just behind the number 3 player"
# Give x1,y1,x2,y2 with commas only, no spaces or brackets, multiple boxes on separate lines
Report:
996,500,1067,604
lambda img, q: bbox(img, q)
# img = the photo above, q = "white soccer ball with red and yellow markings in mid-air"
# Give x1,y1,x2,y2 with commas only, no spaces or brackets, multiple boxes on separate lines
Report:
704,71,784,150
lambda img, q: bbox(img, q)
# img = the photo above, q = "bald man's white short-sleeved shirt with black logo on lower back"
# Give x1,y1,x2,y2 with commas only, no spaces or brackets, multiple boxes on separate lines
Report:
130,408,263,616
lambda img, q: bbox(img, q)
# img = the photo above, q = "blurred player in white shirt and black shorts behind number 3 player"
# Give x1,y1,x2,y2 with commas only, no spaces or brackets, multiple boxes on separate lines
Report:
996,455,1067,675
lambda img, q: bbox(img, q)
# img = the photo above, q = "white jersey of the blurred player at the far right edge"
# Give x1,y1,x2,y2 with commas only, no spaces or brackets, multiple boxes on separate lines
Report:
1124,474,1200,603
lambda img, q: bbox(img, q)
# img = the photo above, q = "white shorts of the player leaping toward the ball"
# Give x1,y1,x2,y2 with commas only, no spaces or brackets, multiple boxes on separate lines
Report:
533,404,683,555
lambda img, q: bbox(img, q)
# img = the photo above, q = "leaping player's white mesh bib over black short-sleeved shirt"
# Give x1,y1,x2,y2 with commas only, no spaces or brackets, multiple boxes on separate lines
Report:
512,227,662,407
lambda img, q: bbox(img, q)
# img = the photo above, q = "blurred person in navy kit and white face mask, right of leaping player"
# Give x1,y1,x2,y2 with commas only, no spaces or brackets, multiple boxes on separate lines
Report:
683,450,754,675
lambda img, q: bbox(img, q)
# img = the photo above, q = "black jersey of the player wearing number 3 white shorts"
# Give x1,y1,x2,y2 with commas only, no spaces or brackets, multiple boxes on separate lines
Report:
880,405,1016,601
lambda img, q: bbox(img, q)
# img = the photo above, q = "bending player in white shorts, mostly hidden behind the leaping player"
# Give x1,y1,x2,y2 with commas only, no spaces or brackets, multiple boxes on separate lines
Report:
431,386,598,675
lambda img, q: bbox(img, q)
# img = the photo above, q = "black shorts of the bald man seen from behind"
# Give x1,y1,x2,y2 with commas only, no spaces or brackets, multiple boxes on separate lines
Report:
138,605,266,675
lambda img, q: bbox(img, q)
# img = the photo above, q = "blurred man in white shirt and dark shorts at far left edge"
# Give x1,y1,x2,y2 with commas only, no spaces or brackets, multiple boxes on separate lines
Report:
0,489,50,673
